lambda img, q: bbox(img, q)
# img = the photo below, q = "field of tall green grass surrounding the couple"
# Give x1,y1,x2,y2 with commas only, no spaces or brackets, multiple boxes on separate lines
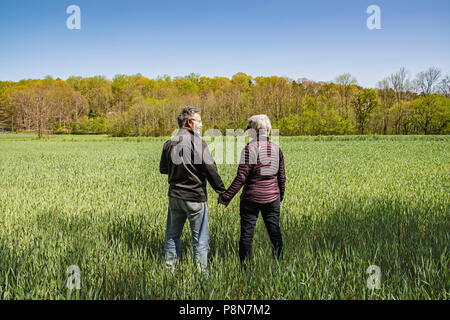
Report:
0,134,450,299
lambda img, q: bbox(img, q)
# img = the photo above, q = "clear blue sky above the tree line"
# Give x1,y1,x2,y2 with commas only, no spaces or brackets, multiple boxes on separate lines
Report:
0,0,450,87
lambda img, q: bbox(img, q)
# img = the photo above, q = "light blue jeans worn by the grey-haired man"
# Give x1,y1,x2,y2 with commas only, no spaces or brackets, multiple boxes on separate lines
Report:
164,197,209,272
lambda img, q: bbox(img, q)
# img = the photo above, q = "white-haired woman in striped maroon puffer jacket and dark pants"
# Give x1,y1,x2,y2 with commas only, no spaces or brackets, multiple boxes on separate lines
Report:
218,115,286,264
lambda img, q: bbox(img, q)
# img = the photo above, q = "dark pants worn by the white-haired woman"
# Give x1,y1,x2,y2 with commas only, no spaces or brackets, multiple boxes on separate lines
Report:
239,198,283,264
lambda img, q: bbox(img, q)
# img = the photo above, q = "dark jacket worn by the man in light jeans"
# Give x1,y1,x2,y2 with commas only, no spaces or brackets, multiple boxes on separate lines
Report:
159,128,226,202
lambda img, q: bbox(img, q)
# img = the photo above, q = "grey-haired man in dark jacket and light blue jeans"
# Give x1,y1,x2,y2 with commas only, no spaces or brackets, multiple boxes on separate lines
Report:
160,106,225,273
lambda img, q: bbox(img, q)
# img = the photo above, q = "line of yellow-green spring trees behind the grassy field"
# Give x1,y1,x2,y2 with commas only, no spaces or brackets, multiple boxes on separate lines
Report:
0,68,450,137
